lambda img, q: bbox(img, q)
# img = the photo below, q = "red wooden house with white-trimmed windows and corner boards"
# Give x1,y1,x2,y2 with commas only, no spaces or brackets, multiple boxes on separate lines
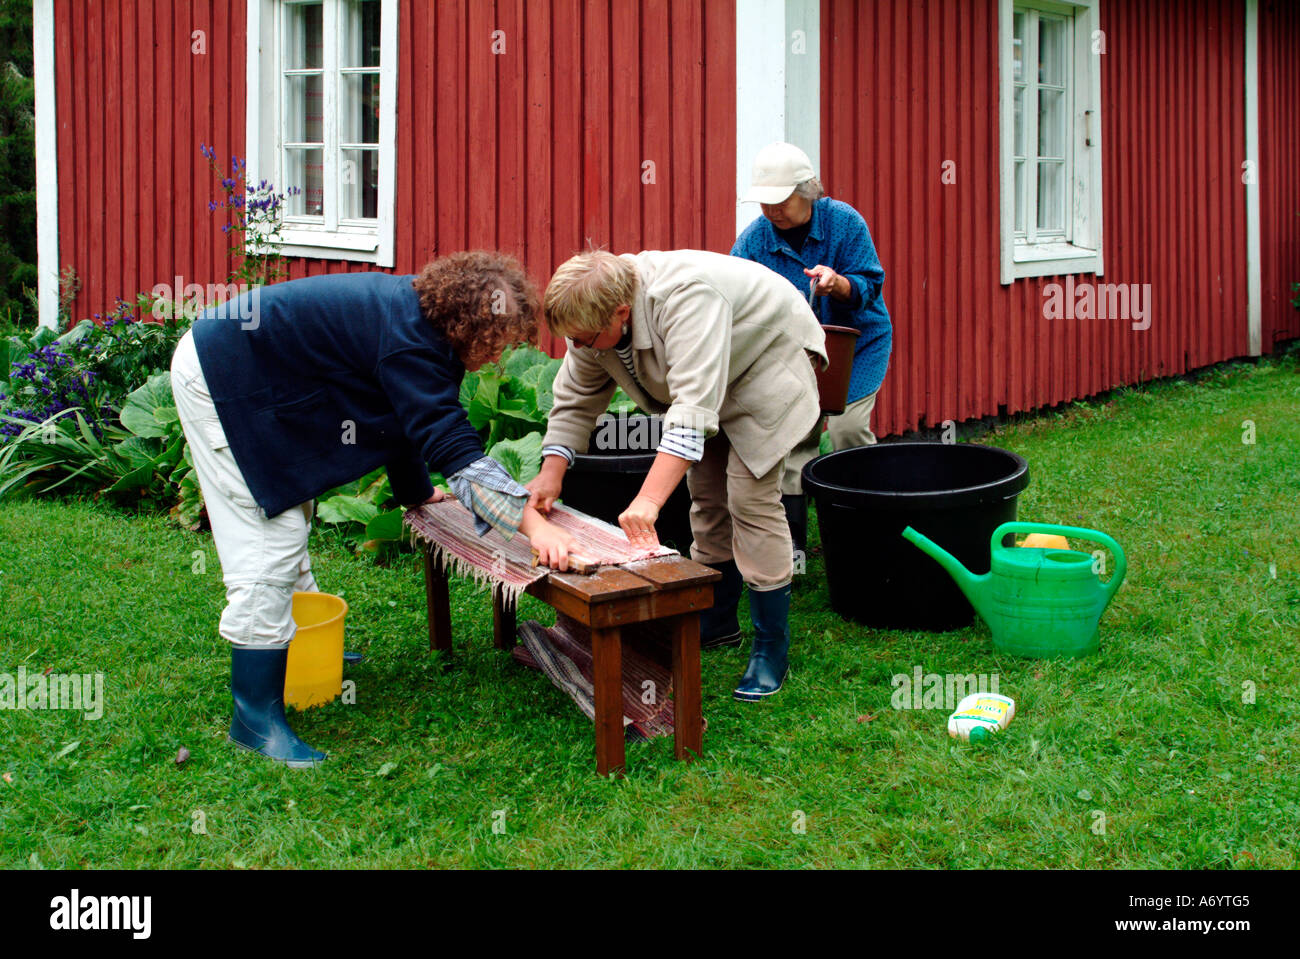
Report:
35,0,1300,433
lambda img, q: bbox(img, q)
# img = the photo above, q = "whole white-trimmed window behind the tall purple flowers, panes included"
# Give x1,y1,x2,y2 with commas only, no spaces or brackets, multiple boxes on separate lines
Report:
248,0,398,266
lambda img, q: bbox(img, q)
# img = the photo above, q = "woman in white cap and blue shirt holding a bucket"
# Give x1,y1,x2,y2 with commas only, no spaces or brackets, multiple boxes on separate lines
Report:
732,143,893,554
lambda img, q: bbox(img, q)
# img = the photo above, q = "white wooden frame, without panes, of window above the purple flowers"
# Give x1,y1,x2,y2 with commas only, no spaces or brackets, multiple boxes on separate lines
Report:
246,0,398,266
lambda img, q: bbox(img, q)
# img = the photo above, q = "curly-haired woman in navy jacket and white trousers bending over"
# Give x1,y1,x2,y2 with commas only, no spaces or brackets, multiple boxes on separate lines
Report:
172,252,572,767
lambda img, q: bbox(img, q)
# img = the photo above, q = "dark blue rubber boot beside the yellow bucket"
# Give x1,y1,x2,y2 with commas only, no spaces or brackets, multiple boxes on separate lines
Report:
230,646,325,769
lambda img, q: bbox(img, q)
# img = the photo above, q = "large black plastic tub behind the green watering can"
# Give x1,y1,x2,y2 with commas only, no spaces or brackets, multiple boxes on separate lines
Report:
803,443,1030,630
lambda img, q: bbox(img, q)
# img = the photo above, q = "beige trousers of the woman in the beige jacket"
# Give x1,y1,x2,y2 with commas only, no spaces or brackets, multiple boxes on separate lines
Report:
686,431,794,593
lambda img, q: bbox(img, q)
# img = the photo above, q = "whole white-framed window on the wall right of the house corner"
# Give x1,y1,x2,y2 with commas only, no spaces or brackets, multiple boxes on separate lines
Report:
1000,0,1105,283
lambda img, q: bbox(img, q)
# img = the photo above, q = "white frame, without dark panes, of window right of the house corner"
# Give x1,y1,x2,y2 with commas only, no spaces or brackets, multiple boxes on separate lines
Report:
998,0,1105,285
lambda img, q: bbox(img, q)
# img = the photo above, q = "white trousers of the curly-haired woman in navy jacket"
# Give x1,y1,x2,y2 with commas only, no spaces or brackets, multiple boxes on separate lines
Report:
172,324,317,647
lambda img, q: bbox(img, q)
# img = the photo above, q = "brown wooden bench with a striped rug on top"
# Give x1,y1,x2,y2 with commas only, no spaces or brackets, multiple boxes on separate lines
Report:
424,546,722,776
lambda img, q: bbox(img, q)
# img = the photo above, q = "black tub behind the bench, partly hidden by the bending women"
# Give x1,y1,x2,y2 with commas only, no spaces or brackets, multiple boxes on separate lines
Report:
560,416,692,556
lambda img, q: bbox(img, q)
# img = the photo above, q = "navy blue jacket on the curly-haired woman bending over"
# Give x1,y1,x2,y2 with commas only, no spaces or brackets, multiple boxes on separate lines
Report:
194,273,482,516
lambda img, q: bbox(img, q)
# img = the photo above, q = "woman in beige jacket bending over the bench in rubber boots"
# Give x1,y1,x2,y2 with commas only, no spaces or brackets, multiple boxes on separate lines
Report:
528,249,826,702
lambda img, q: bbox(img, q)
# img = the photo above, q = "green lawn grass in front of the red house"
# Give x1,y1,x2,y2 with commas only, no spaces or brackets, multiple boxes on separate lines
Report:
0,355,1300,868
